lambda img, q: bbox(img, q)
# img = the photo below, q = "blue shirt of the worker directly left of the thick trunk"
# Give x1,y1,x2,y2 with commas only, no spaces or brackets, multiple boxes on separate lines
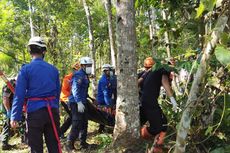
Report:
97,74,112,106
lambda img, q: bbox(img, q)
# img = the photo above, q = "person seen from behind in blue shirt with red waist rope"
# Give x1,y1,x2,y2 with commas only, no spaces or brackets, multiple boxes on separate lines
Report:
11,37,61,153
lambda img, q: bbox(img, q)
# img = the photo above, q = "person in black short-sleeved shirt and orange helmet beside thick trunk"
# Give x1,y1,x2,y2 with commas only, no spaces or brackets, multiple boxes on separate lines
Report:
139,57,177,152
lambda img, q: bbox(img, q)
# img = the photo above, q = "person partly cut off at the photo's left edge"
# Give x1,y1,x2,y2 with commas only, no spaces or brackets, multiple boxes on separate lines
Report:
1,79,16,150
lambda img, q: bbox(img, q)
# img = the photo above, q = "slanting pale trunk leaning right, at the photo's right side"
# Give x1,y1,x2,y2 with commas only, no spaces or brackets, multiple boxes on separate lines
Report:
174,2,229,153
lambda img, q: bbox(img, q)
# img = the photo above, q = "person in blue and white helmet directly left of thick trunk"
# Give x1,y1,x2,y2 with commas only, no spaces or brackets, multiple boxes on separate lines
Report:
97,64,113,133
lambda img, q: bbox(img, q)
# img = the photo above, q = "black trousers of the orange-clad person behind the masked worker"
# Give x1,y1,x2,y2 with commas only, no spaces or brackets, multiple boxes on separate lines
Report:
60,101,72,136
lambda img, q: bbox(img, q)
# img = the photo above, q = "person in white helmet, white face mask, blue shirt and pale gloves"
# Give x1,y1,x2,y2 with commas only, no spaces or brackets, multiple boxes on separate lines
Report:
66,57,93,151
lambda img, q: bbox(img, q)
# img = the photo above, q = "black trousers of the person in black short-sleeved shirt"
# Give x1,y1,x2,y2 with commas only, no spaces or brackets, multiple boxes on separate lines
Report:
140,103,168,135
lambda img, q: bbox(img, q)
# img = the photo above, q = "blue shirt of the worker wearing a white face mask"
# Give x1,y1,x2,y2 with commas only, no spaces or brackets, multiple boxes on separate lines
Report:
69,69,89,103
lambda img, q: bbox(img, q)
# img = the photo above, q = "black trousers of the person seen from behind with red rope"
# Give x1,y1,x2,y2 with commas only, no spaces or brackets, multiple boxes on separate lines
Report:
27,107,60,153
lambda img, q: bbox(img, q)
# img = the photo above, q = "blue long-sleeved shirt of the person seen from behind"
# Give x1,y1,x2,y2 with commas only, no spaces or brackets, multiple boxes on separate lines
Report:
11,58,60,121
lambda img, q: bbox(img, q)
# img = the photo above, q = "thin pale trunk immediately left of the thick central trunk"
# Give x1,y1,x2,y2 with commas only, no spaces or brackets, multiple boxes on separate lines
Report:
104,0,116,67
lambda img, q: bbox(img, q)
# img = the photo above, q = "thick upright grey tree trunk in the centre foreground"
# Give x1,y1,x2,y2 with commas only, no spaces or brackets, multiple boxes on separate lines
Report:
113,0,140,149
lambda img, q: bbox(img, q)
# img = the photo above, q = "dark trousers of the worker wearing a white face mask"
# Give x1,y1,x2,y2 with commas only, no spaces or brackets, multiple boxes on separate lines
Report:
67,103,88,144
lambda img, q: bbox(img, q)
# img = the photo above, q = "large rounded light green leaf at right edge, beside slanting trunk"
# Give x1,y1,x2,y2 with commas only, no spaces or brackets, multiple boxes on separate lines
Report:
215,45,230,65
